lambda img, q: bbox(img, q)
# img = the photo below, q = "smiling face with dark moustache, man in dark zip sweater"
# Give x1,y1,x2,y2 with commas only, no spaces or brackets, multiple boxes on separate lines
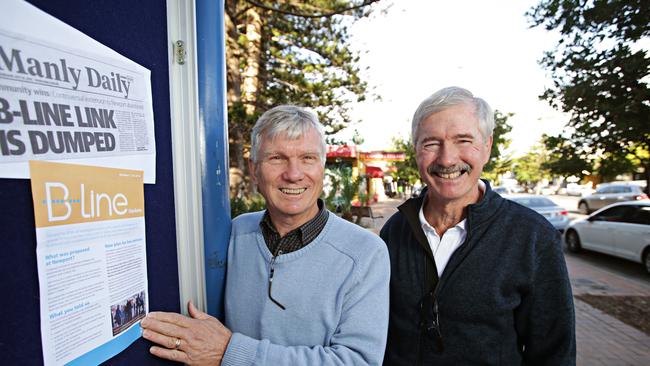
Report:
415,104,492,207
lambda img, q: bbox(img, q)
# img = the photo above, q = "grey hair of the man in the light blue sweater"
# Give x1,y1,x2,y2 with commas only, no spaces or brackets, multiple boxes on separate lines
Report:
251,104,327,166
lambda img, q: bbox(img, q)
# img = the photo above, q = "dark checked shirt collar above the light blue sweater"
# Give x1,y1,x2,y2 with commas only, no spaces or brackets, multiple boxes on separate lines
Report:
260,198,328,256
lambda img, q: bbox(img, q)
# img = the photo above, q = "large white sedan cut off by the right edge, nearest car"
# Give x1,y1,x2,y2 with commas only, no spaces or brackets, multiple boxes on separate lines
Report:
564,200,650,273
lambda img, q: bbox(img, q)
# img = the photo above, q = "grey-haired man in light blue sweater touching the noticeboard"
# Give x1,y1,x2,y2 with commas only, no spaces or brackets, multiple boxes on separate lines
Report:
142,106,390,366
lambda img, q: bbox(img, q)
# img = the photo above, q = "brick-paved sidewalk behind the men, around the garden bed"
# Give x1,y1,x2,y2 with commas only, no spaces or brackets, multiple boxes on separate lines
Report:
362,198,650,366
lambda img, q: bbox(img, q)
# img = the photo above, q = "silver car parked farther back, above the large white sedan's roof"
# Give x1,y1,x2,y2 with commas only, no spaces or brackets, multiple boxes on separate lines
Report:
578,183,648,215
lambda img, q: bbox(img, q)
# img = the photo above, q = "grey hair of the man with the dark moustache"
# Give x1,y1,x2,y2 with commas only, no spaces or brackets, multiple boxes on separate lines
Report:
411,86,494,148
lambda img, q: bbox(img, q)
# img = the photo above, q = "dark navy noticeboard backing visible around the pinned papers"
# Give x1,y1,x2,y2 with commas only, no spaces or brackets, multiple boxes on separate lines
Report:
0,0,180,365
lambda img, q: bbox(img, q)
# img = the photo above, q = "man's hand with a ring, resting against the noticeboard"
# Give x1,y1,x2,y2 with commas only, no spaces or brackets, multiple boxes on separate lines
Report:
140,301,232,366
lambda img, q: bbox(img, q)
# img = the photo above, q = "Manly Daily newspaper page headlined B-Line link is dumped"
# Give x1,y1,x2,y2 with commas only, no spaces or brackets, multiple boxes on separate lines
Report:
0,2,155,183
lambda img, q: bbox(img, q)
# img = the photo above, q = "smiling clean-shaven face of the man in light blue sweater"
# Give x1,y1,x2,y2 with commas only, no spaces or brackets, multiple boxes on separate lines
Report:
250,130,324,235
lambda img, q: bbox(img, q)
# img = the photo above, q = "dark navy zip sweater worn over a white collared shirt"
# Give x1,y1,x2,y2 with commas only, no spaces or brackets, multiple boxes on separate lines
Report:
381,182,575,366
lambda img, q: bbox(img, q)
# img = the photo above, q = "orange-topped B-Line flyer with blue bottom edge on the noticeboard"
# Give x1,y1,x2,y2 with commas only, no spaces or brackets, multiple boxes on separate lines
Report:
30,161,149,365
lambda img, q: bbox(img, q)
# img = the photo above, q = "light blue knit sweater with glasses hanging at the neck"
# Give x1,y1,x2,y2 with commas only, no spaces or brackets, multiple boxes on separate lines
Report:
222,212,390,366
